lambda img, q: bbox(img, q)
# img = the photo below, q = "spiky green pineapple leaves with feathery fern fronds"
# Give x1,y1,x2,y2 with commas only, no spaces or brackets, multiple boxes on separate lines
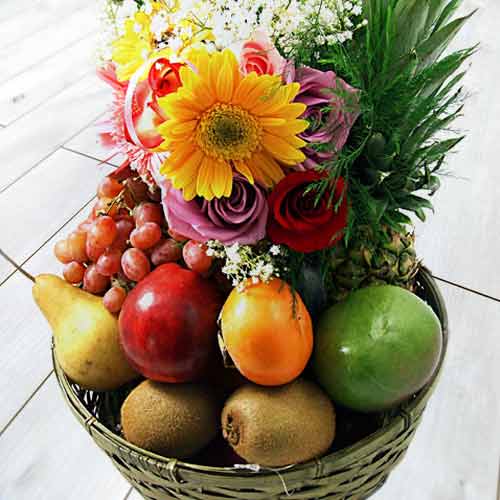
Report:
303,0,475,246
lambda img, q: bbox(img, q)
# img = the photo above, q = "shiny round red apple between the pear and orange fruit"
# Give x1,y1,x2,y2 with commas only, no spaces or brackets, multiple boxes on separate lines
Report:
119,263,223,383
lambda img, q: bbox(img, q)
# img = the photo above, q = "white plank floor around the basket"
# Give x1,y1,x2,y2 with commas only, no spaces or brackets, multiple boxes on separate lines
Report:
0,0,500,500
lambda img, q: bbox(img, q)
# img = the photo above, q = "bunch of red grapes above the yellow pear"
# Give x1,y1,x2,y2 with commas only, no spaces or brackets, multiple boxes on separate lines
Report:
54,177,212,313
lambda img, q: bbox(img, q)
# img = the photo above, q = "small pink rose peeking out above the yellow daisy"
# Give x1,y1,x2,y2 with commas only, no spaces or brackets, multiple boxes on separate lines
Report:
241,31,286,75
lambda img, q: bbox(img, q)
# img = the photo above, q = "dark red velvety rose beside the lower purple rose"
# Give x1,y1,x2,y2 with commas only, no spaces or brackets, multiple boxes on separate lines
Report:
267,170,348,253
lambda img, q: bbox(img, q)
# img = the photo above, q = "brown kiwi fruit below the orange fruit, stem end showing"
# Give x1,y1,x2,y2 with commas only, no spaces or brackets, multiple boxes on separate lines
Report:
222,379,335,467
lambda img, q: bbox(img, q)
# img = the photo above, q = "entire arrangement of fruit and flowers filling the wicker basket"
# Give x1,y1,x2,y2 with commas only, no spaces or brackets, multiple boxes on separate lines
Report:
26,0,474,476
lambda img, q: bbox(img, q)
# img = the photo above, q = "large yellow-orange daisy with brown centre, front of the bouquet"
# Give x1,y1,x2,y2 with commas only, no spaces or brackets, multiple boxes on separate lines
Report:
158,49,308,200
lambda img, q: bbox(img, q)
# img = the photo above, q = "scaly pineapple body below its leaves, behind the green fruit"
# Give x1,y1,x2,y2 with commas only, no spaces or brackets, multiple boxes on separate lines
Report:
329,226,419,302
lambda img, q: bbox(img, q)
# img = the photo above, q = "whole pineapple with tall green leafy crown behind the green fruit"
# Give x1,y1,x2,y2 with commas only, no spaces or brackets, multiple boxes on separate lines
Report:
323,0,475,302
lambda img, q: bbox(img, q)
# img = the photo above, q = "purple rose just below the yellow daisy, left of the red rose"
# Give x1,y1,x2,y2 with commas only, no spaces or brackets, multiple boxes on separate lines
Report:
163,175,269,245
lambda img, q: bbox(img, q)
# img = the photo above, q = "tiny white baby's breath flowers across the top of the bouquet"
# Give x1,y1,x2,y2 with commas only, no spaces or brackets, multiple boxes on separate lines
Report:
100,0,364,63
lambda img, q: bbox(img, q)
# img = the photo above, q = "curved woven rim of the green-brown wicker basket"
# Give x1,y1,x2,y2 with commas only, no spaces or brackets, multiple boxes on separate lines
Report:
52,267,448,477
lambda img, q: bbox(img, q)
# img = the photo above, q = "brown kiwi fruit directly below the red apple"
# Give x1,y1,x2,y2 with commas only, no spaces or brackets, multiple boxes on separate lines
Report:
121,380,219,459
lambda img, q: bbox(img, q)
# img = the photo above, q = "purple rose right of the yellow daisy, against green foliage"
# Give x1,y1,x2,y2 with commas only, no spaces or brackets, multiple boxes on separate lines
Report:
287,66,359,169
